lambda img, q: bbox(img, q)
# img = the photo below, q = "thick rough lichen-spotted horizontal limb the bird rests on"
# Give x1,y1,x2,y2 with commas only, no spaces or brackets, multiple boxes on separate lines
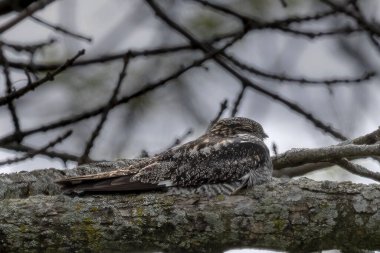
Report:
0,160,380,252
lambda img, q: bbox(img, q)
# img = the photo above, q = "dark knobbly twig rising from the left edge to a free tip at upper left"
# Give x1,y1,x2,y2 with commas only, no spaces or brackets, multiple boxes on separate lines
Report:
0,50,85,106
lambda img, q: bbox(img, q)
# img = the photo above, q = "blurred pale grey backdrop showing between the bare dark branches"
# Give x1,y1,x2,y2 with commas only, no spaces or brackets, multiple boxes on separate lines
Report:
0,0,380,182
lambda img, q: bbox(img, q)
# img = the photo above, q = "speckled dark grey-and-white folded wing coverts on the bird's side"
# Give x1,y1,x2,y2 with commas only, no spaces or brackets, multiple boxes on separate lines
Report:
131,135,270,187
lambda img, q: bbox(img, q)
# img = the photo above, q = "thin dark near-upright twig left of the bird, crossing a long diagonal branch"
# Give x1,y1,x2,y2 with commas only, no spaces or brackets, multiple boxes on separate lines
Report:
78,55,129,164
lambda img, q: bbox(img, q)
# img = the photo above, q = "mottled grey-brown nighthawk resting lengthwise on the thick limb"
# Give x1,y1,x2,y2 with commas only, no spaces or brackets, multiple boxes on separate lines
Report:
57,117,272,194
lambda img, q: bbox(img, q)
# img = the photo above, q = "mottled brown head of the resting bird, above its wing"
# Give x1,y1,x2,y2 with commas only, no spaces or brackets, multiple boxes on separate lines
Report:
207,117,268,140
